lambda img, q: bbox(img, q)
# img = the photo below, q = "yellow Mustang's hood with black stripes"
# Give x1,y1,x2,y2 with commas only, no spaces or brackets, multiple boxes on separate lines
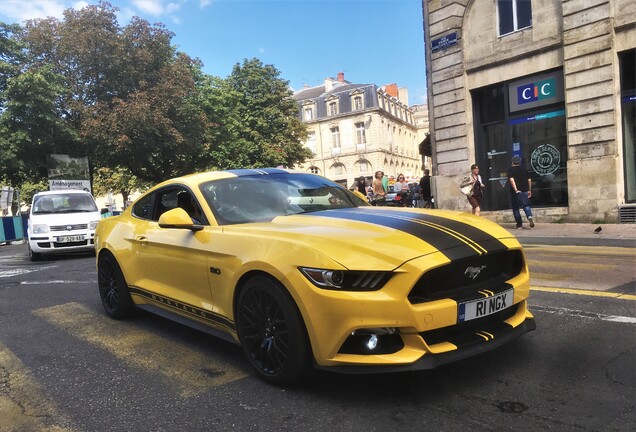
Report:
229,207,516,270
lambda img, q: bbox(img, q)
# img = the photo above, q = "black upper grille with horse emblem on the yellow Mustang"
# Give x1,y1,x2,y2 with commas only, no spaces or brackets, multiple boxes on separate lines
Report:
408,250,524,304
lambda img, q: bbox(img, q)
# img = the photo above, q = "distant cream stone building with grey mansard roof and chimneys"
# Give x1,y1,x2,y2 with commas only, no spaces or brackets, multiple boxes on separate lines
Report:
294,73,428,187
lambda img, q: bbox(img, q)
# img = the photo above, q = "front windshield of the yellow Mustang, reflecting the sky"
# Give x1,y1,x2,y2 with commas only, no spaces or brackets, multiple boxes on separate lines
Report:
201,173,368,225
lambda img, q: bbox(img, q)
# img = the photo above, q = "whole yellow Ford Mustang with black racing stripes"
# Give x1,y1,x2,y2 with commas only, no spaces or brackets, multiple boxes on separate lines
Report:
95,169,535,385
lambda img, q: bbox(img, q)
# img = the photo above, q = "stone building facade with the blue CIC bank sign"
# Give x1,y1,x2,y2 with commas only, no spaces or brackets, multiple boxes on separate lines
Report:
422,0,636,222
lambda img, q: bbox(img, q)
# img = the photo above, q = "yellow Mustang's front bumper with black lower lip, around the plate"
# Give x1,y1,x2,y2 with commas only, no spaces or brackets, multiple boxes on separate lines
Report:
287,250,536,373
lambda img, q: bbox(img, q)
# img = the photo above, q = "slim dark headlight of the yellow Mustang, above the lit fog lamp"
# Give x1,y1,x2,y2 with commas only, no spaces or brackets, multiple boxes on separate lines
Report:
299,267,392,291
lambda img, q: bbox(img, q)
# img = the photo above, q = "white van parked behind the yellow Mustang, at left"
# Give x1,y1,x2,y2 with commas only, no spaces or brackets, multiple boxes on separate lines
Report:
27,190,101,261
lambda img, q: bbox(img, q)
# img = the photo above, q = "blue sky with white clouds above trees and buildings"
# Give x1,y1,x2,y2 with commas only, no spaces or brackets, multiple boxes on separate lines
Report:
0,0,426,105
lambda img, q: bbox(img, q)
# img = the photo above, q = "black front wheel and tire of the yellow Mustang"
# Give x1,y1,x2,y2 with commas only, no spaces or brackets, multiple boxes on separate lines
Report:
236,276,310,386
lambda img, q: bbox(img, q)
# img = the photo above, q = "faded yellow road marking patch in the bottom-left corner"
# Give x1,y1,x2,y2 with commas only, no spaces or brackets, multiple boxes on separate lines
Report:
0,343,73,432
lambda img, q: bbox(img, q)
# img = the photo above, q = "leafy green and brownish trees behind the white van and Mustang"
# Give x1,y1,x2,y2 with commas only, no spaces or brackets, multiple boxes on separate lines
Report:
0,1,311,189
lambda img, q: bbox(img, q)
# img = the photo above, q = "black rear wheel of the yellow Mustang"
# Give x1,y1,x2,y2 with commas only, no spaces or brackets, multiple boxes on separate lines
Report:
97,252,135,319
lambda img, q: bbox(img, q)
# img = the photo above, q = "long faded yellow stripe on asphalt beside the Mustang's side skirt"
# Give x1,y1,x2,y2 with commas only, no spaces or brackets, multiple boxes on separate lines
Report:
33,303,246,397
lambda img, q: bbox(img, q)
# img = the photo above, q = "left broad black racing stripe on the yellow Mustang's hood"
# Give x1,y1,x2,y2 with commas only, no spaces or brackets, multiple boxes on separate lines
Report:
311,209,483,260
